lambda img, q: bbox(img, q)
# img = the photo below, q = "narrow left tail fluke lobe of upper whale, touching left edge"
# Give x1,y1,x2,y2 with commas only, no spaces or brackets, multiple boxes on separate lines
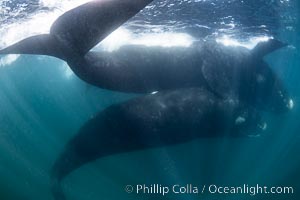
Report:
0,34,64,59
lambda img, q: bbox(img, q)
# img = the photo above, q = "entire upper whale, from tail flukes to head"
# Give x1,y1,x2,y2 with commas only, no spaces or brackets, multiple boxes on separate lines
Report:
0,0,293,112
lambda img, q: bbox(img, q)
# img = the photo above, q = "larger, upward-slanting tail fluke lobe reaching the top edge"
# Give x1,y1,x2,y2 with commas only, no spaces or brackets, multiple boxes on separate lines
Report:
50,0,153,55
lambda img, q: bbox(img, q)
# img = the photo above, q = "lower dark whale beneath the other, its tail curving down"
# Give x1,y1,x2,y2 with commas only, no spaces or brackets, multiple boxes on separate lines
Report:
52,88,262,199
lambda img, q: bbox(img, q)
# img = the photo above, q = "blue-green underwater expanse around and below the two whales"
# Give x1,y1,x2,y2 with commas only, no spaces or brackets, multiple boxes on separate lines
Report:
0,1,300,200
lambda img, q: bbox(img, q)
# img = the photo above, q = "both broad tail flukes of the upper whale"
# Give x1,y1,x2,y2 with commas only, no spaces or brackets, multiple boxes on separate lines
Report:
0,0,153,61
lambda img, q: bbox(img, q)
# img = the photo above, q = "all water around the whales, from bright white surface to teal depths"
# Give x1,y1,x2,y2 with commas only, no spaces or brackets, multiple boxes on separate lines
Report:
0,0,300,200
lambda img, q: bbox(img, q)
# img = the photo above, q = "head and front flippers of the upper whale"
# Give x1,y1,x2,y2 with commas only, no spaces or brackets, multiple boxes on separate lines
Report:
202,39,293,113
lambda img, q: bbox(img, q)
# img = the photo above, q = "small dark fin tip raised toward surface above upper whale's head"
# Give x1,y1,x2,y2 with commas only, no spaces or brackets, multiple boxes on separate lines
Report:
251,39,288,59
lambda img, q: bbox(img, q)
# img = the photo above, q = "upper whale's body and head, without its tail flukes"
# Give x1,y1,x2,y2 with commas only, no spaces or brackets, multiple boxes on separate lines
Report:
74,40,291,113
